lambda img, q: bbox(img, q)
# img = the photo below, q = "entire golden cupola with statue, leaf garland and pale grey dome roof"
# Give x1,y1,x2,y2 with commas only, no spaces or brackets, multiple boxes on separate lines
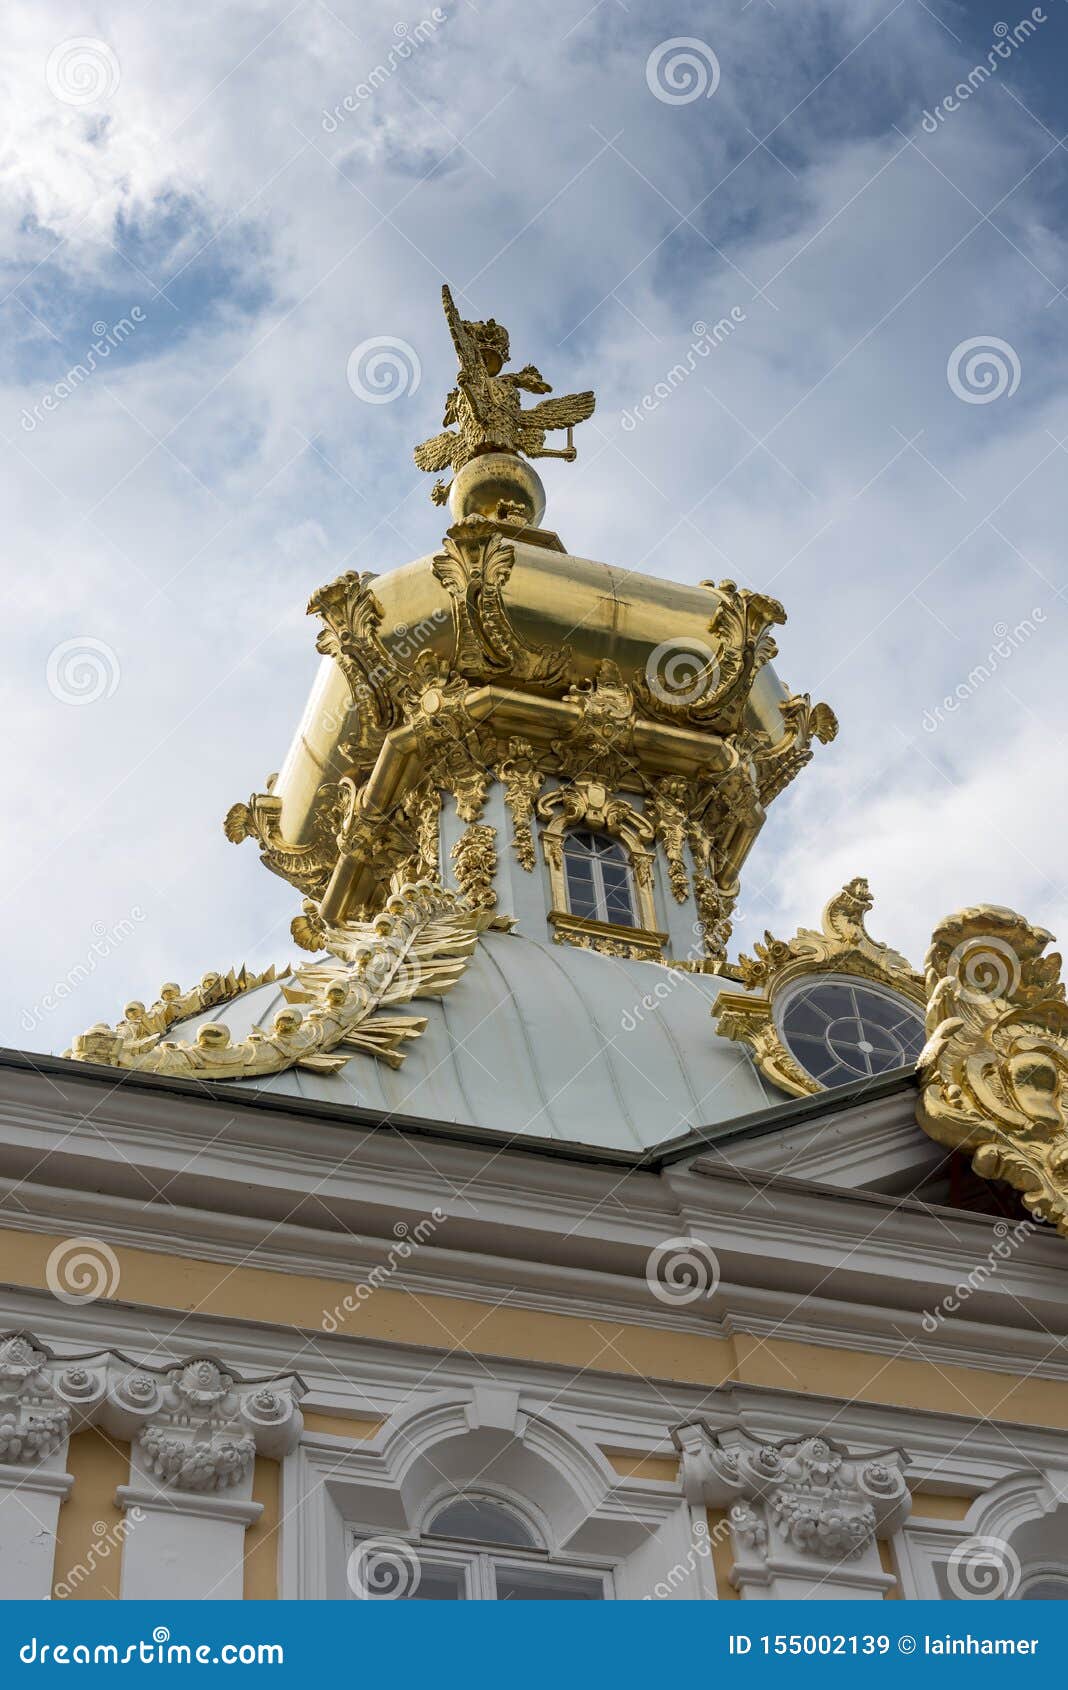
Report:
71,289,836,1149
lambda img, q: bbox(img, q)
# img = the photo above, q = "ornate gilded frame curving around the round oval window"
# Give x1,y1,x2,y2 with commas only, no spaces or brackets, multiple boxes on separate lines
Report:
713,877,926,1097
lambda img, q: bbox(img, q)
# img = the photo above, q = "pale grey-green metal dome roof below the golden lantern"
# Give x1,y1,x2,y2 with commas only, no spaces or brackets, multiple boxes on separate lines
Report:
174,931,781,1151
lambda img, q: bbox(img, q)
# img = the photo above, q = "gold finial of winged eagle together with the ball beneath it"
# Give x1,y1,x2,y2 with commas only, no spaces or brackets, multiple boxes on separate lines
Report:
416,286,597,527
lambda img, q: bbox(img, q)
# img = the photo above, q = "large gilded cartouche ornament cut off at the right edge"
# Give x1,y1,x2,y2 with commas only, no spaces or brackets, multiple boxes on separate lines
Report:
916,904,1068,1235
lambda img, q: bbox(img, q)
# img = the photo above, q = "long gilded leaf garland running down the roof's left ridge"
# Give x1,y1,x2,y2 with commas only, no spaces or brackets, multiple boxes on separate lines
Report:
68,882,488,1080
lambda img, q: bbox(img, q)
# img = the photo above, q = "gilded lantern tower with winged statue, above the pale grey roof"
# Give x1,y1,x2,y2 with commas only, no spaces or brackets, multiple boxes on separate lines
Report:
226,287,836,972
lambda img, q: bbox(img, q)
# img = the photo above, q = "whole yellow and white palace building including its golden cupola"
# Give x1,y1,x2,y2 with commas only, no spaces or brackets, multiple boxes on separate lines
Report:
8,291,1068,1600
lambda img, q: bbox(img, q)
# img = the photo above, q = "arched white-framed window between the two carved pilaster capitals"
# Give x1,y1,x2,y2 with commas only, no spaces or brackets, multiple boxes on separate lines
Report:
348,1496,610,1602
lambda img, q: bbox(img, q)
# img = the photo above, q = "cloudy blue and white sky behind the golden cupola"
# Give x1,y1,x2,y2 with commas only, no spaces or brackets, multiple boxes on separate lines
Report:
0,0,1068,1049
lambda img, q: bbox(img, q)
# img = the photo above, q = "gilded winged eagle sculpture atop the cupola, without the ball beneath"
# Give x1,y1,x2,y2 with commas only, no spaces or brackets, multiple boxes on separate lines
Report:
416,286,597,505
